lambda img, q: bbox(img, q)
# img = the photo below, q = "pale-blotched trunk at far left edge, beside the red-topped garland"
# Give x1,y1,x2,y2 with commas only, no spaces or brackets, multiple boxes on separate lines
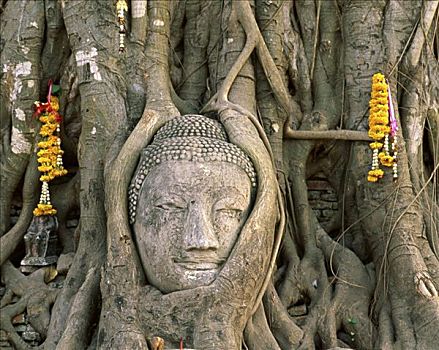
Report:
0,2,46,237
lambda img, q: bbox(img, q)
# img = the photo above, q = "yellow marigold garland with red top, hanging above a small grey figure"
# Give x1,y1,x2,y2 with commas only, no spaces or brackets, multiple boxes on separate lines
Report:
33,82,67,216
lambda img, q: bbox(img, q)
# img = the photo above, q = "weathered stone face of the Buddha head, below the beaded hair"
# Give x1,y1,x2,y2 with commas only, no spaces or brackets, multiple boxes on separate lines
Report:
133,160,251,293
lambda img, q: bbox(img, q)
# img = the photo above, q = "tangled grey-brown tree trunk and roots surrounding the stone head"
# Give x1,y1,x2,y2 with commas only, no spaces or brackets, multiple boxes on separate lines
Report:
0,0,439,350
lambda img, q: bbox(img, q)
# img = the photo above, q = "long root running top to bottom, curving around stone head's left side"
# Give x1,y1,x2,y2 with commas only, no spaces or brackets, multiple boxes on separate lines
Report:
98,1,179,349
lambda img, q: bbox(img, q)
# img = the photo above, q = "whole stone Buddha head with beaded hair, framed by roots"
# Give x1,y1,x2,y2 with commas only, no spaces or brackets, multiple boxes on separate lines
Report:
129,115,256,293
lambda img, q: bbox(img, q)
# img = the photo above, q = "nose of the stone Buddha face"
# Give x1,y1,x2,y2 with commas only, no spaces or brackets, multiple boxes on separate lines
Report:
183,203,219,251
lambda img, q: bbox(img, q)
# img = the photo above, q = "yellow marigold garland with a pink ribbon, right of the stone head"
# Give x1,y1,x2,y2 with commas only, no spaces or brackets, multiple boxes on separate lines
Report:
367,73,398,182
